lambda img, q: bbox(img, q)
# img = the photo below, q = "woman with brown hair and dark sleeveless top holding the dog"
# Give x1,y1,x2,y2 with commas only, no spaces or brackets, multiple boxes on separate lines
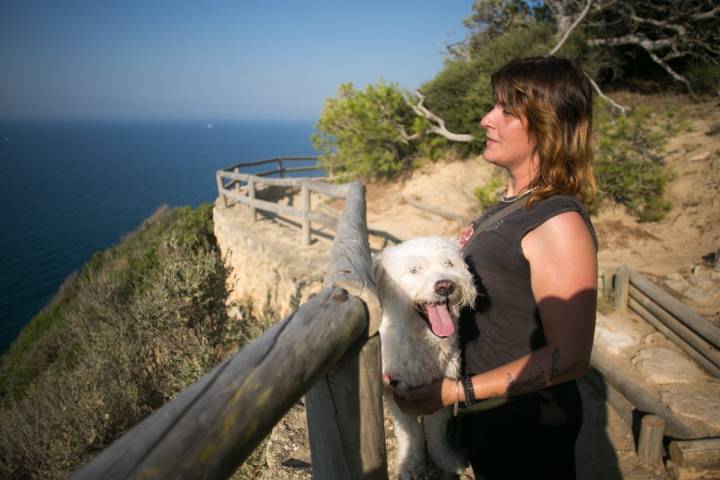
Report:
397,57,597,479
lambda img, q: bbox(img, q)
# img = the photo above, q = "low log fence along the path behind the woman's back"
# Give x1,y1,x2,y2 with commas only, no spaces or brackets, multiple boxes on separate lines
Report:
592,266,720,478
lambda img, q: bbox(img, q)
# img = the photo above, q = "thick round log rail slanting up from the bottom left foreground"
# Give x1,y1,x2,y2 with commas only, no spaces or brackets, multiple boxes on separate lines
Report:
71,288,367,480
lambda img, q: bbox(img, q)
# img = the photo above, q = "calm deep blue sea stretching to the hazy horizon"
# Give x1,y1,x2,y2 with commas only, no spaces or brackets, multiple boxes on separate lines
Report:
0,121,315,353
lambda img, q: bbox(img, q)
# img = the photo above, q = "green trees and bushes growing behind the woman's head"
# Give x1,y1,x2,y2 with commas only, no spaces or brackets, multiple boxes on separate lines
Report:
314,0,720,220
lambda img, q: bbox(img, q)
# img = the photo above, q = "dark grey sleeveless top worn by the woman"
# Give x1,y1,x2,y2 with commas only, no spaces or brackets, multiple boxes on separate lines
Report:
461,195,597,374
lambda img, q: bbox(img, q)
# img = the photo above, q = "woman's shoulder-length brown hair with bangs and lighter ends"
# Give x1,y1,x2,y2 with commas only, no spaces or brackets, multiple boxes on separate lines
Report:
491,57,596,205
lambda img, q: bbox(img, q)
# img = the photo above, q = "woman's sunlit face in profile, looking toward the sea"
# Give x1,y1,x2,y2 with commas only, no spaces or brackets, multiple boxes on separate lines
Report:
480,104,535,170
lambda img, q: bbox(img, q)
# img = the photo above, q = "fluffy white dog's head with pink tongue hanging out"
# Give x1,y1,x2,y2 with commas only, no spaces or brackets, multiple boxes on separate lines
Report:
375,237,476,337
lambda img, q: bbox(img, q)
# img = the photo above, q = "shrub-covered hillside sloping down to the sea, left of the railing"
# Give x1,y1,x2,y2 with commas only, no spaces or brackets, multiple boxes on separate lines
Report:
0,205,272,479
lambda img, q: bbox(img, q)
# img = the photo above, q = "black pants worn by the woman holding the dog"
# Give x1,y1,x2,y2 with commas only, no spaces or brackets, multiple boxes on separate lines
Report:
463,382,582,480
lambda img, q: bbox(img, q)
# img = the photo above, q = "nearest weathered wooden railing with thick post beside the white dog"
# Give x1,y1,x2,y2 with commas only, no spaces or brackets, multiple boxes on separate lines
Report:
71,183,387,480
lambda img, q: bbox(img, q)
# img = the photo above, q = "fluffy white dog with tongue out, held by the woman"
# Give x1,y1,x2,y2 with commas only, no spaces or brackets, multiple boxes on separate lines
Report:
375,237,476,480
